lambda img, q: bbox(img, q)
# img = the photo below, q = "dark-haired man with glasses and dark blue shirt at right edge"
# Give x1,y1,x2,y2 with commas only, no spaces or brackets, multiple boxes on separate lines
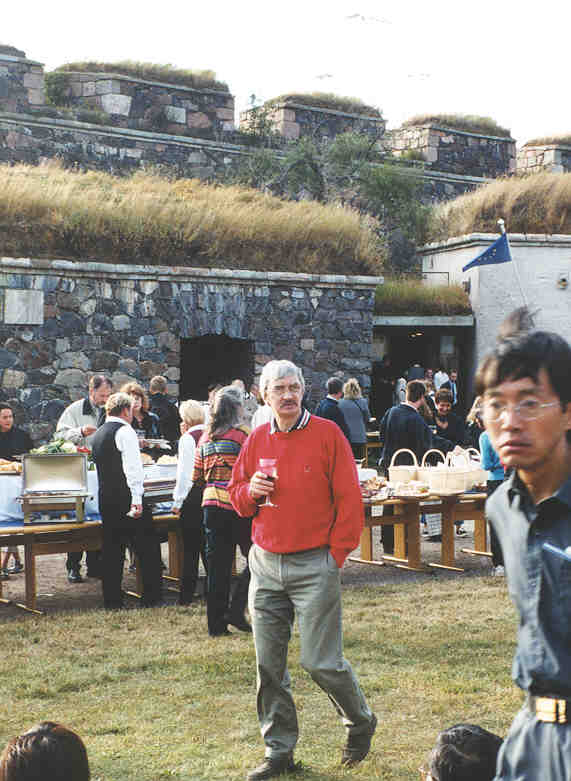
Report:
476,312,571,781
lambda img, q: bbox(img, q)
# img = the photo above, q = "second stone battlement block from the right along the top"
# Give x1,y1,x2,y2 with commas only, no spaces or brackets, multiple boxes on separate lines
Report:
387,125,516,178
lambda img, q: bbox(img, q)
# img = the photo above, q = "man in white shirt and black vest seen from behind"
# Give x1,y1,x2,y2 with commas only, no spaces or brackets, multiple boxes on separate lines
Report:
91,393,162,608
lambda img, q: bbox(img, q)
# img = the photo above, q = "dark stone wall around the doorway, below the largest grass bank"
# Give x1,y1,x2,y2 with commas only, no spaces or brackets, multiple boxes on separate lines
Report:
0,258,382,441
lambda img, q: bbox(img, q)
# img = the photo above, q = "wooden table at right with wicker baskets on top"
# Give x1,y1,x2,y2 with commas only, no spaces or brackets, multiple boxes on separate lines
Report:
349,493,487,572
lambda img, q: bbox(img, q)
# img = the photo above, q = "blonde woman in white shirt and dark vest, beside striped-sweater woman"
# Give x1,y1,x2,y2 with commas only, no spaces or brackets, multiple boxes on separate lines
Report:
172,399,208,605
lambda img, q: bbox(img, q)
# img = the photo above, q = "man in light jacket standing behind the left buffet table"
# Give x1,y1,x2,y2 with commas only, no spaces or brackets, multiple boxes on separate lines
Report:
55,374,113,583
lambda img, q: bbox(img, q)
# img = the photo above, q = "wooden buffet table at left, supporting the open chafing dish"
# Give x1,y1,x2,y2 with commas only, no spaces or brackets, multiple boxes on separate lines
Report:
0,513,183,615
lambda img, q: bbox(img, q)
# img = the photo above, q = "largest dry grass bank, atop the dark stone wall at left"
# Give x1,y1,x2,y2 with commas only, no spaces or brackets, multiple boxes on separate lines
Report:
0,164,384,274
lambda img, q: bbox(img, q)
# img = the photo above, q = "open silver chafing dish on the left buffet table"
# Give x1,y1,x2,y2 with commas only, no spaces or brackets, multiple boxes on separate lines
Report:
20,453,89,523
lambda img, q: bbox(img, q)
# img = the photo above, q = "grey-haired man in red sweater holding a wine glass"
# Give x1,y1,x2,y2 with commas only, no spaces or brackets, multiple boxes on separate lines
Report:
228,361,377,781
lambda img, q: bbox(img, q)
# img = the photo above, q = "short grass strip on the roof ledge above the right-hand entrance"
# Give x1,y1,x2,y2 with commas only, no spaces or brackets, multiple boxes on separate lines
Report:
375,279,472,315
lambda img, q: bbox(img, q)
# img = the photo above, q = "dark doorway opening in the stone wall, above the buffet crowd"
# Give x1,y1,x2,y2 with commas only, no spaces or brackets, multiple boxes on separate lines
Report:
180,334,254,401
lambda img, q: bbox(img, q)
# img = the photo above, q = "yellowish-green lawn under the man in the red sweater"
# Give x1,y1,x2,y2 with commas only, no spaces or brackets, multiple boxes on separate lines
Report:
0,577,521,781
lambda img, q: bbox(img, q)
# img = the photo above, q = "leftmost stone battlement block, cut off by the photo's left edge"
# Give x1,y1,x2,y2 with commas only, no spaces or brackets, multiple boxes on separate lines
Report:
0,46,45,113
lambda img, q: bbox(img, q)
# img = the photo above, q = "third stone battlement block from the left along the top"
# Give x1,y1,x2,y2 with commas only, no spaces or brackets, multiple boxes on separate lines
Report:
240,103,387,141
